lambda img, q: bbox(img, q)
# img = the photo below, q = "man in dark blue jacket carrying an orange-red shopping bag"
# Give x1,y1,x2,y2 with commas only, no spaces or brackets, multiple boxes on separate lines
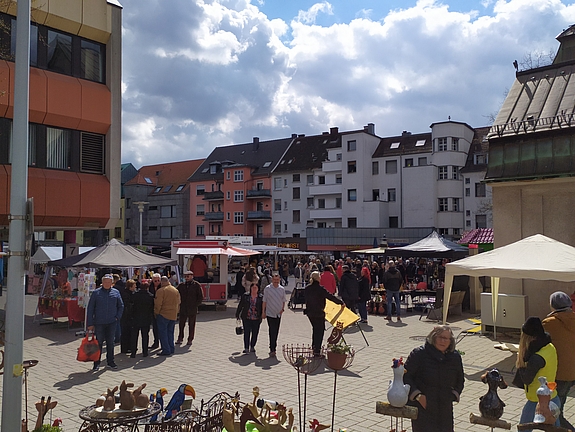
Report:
86,274,124,371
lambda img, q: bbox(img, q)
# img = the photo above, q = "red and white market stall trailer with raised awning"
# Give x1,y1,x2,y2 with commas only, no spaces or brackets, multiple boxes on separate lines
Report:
172,240,259,304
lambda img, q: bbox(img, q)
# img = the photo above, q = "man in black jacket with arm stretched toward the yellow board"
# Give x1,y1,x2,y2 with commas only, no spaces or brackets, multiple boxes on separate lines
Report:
304,271,343,357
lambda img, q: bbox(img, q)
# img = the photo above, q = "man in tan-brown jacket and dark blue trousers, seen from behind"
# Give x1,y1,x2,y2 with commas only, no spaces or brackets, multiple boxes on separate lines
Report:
154,276,180,356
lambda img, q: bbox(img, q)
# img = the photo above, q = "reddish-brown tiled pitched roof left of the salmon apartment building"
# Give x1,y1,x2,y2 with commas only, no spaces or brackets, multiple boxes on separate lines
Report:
126,159,204,193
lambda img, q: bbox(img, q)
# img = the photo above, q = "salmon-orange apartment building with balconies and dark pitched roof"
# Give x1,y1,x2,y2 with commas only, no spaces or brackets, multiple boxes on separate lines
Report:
188,138,292,239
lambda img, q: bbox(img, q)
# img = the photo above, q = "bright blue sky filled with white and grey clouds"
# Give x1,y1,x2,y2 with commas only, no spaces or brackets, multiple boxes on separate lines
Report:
121,0,575,168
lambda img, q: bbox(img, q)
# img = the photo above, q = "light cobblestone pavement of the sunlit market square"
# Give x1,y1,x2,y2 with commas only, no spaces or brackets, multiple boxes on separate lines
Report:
0,281,575,432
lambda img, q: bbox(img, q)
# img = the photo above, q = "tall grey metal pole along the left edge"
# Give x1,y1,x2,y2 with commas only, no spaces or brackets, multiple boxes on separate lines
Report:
2,0,30,431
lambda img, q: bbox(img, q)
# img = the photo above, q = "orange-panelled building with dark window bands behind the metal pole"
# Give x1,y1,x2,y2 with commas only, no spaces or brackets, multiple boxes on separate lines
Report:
0,0,122,231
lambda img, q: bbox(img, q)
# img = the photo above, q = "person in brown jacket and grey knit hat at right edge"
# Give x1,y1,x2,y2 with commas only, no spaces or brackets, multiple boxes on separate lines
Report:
543,291,575,430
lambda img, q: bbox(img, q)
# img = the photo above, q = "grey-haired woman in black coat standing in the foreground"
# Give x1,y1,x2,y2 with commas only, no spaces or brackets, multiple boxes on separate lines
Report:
404,326,464,432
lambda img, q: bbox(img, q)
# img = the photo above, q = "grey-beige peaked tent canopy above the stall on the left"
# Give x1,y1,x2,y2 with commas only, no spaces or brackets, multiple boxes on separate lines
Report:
49,239,176,268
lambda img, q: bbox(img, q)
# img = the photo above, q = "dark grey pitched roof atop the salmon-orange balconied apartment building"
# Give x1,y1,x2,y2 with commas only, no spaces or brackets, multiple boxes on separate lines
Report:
188,138,292,181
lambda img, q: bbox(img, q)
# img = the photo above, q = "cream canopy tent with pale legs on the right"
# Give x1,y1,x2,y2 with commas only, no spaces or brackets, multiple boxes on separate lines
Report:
443,234,575,323
